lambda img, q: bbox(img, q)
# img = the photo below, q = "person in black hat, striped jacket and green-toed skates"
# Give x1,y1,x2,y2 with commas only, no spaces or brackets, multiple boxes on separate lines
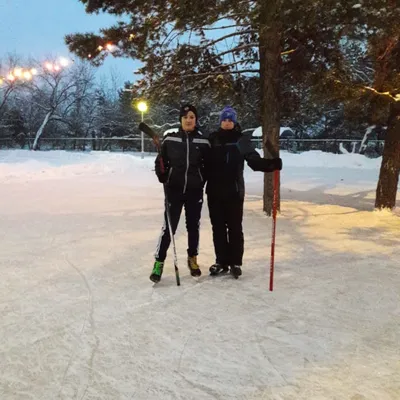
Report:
150,104,210,282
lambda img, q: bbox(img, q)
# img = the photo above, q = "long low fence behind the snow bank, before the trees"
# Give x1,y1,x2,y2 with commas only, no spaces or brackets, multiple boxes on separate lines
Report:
0,137,384,157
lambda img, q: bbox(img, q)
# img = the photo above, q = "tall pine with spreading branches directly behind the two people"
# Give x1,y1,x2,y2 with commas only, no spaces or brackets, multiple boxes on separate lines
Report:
66,0,398,215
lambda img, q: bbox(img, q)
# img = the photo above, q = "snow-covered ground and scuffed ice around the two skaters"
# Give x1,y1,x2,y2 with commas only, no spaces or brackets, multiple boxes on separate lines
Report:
0,151,400,400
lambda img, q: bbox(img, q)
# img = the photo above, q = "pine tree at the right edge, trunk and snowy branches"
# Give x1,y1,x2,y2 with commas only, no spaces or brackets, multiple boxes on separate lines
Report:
312,0,400,209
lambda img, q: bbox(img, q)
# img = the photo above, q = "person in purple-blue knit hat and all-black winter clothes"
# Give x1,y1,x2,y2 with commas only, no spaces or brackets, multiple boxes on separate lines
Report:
206,107,282,278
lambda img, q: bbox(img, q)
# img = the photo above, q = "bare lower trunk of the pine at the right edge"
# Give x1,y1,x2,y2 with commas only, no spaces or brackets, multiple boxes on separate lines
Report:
375,101,400,210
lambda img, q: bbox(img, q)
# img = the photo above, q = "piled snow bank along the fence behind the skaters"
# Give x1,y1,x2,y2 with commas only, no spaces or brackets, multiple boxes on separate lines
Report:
0,150,381,183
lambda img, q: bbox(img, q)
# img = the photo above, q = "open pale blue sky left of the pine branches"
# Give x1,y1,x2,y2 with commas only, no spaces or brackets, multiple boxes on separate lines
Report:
0,0,139,83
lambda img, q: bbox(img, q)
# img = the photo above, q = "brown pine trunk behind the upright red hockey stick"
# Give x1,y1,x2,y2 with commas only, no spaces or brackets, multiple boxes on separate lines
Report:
260,0,282,216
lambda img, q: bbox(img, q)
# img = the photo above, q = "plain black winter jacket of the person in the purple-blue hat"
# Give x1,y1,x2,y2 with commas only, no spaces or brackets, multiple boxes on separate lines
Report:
207,125,282,198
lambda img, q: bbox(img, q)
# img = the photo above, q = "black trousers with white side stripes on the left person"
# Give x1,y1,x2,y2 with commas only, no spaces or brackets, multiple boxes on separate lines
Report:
154,189,203,261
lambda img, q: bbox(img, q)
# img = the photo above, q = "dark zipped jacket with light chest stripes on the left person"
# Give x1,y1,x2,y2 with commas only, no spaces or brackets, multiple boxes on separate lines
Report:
155,128,210,193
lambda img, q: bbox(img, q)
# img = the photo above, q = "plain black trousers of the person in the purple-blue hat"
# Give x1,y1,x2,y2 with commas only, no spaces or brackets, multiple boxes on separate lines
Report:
208,194,244,265
